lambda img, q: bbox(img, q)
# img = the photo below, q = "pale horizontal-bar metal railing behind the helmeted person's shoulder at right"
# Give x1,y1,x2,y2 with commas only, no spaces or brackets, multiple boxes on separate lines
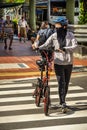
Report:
68,25,87,58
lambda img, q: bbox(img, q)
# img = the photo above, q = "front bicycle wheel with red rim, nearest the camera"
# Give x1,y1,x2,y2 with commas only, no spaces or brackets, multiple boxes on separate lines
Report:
44,87,50,116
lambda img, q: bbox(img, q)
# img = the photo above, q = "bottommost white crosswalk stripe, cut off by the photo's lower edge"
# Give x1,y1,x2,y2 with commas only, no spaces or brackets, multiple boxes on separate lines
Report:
12,124,87,130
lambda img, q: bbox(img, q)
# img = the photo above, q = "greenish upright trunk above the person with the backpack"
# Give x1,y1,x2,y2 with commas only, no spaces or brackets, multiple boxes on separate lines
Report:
29,0,36,30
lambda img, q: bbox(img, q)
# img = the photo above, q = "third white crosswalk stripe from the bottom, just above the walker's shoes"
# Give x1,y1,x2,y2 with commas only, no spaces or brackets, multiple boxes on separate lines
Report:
0,100,87,112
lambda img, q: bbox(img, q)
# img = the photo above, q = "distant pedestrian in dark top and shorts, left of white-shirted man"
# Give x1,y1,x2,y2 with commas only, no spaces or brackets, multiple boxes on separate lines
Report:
4,15,14,50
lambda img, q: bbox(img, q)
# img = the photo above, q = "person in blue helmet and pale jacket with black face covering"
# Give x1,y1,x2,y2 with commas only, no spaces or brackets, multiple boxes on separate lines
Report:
34,18,78,113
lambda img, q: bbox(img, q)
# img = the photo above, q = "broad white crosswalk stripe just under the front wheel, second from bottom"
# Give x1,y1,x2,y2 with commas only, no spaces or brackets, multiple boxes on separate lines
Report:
0,110,87,124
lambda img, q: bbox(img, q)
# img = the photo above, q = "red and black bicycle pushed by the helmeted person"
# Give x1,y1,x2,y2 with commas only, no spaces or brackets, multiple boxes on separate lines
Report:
33,48,53,116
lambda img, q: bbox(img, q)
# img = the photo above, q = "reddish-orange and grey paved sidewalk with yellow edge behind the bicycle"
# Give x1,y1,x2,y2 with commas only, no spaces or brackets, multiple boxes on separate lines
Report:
0,40,87,79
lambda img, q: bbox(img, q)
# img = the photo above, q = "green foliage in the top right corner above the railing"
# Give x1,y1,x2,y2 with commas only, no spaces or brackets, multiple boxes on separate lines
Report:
78,0,87,24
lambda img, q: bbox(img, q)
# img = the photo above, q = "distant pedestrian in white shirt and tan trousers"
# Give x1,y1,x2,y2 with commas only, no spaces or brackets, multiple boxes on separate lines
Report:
18,16,28,42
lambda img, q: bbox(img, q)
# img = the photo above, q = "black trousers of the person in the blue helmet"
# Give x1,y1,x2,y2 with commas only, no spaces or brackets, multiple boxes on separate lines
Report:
54,64,73,104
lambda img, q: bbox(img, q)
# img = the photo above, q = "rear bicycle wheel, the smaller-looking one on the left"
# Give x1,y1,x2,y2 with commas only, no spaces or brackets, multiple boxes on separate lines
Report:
35,86,41,107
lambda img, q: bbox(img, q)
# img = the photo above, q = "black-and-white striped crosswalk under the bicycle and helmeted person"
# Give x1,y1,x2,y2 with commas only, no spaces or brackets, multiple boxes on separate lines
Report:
0,79,87,130
